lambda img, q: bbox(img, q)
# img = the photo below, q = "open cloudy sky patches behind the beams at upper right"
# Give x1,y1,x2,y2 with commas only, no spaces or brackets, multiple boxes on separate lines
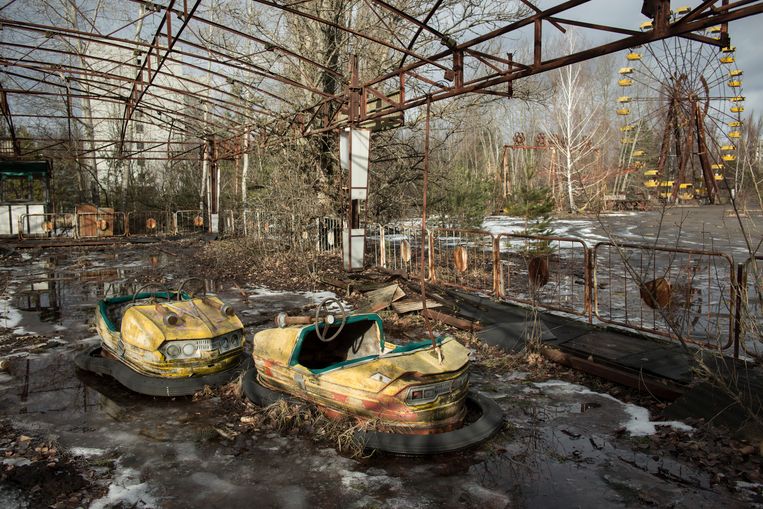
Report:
539,0,763,114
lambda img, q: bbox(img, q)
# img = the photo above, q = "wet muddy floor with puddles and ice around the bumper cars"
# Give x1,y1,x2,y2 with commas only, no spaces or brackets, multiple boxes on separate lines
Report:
0,248,756,509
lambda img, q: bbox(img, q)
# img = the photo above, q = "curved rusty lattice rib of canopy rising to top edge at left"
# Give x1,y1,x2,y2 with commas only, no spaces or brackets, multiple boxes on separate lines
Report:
119,0,201,152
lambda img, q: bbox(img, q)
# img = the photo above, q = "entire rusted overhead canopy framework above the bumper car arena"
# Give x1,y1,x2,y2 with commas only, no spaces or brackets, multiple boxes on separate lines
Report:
0,0,763,161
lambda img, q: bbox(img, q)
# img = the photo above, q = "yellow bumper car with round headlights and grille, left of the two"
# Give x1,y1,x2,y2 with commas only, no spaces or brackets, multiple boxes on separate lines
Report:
75,278,245,396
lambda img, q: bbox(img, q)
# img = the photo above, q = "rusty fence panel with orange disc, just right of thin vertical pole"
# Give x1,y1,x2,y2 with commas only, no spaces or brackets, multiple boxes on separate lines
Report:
430,228,495,294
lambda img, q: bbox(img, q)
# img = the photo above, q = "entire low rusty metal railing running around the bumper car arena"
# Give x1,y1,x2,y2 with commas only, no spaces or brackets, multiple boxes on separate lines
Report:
10,206,763,361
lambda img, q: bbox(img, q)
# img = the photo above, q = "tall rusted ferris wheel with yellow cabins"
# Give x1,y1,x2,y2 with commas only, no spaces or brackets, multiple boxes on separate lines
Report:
615,7,744,203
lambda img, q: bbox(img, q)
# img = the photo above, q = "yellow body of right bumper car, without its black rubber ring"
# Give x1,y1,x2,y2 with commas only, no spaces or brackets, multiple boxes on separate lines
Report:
252,314,469,434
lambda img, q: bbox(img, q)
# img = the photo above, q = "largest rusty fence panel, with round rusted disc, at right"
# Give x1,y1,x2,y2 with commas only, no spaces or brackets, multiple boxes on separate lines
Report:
593,242,736,348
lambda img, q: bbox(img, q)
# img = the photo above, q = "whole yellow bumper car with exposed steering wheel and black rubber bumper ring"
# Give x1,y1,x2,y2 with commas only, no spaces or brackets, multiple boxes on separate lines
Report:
244,299,503,454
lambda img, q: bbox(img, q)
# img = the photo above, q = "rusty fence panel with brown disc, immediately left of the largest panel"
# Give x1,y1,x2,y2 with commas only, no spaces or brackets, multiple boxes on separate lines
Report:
496,233,591,319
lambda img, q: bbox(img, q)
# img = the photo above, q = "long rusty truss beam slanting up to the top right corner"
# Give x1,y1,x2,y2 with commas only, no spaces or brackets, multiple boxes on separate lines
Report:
306,0,763,134
